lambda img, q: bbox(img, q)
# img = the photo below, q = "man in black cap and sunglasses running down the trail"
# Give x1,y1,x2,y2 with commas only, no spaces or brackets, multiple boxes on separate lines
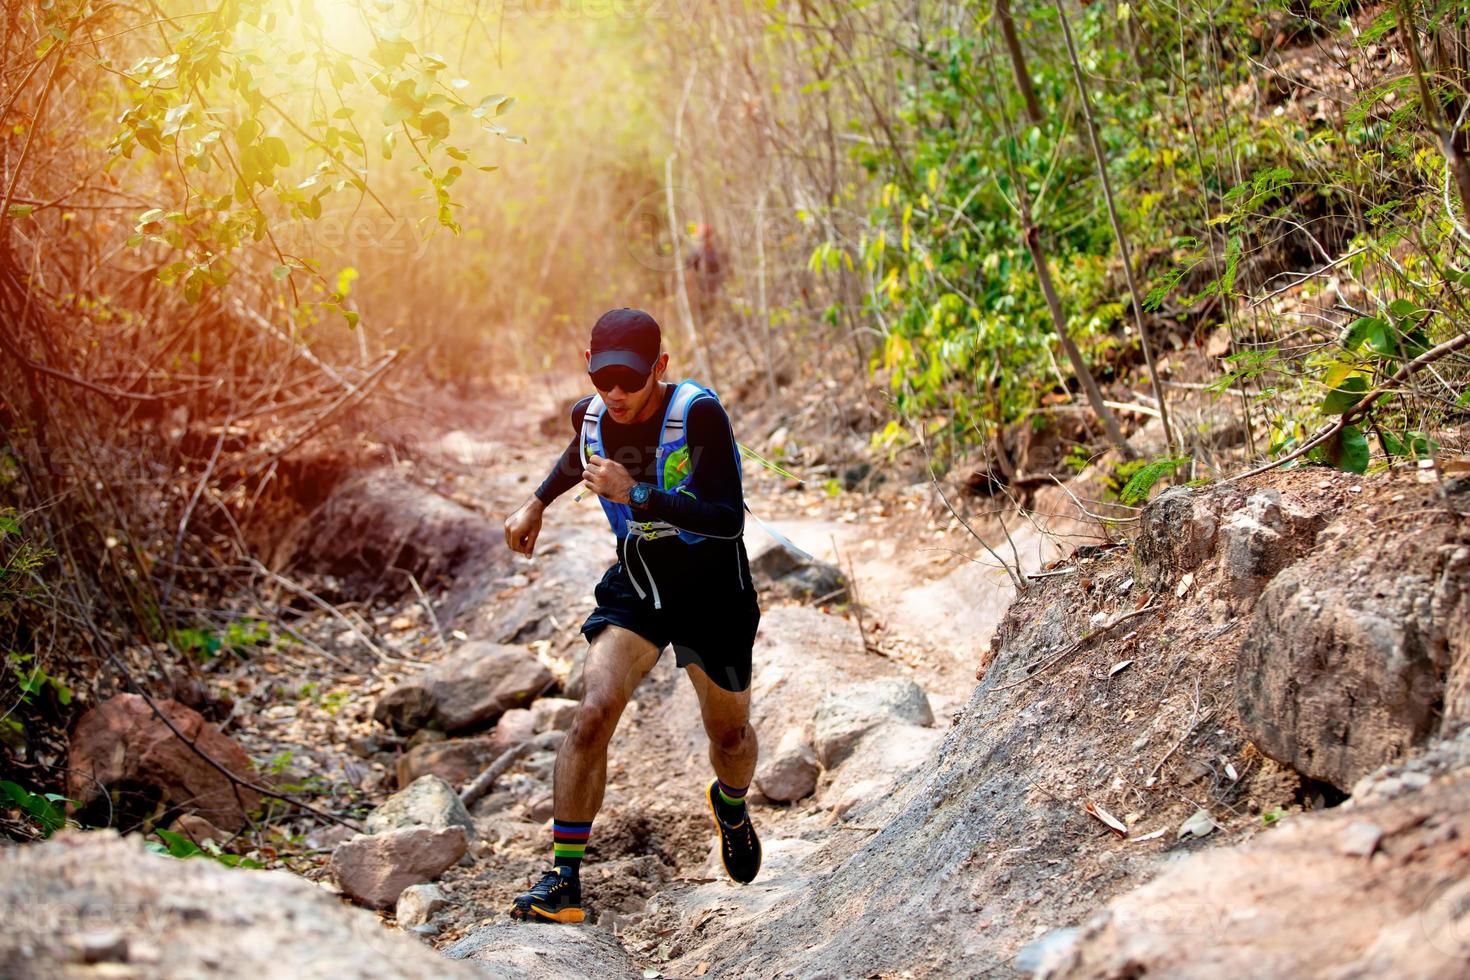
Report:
506,309,760,923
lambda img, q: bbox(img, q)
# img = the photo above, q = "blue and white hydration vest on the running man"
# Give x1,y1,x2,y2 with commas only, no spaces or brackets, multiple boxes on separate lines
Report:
581,379,745,608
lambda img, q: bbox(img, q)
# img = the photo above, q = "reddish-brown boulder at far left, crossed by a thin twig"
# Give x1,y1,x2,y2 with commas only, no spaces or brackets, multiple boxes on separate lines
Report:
66,693,260,830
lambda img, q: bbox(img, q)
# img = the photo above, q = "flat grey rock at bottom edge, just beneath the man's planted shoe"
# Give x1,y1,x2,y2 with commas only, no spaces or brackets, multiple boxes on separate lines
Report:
444,923,647,980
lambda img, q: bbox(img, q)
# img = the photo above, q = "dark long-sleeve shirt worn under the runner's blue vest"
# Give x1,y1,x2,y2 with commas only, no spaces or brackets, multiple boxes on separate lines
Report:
535,385,745,538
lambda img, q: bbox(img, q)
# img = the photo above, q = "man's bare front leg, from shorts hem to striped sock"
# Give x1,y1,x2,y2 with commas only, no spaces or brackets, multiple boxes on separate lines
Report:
551,626,659,821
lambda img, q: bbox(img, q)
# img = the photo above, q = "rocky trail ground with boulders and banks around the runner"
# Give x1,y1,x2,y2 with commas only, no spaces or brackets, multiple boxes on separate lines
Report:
0,379,1470,977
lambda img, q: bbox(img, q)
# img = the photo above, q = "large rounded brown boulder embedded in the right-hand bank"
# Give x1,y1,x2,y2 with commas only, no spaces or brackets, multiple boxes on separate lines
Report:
1236,523,1470,790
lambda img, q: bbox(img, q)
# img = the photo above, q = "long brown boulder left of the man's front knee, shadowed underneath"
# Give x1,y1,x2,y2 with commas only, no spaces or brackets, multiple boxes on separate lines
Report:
373,641,556,733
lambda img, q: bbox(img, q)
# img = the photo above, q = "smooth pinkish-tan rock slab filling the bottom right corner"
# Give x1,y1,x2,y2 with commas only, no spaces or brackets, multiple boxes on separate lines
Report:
1038,734,1470,980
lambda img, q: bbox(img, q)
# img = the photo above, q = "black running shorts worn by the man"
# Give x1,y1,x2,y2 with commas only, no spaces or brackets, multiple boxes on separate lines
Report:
582,561,760,692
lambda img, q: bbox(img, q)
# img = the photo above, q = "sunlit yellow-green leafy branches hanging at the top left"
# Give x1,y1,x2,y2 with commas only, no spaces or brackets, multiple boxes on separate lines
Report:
102,0,523,326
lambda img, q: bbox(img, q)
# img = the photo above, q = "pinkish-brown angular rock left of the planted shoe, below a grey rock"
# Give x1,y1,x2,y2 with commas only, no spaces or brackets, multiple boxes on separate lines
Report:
331,827,469,908
